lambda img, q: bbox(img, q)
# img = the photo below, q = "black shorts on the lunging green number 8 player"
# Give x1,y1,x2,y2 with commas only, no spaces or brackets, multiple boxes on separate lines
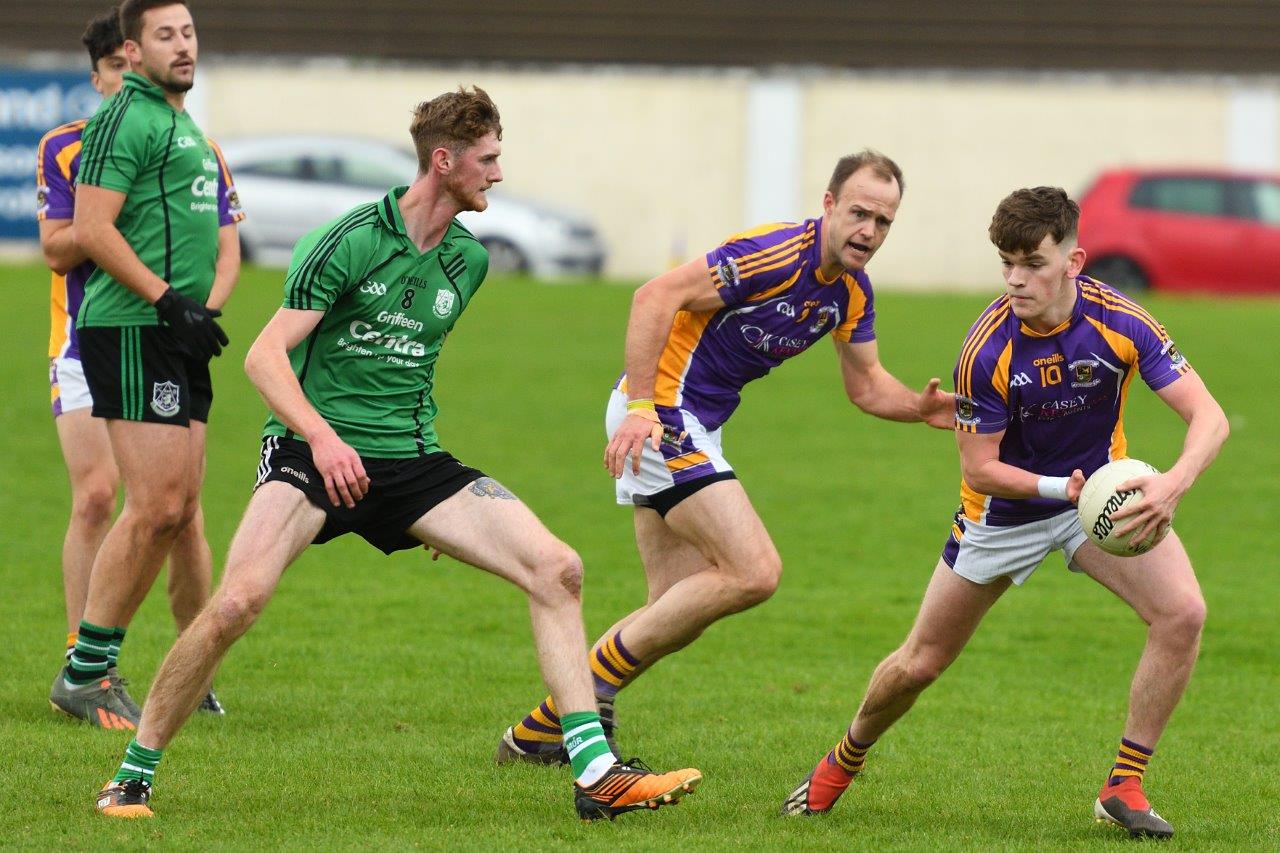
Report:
253,435,484,553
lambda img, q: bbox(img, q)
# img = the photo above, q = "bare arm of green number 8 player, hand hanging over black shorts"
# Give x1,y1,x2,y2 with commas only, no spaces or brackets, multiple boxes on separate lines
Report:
244,307,369,508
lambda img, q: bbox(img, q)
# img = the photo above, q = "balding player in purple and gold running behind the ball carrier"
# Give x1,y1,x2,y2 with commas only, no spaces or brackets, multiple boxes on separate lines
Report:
497,151,954,763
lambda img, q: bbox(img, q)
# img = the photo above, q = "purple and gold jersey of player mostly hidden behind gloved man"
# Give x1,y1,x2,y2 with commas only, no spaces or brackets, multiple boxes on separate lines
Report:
36,119,244,359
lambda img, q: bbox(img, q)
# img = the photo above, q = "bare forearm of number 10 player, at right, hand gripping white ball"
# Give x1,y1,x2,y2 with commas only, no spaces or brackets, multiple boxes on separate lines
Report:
1111,370,1231,542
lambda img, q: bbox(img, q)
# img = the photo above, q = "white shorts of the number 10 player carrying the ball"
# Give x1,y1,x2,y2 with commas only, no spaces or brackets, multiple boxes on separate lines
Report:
942,508,1088,585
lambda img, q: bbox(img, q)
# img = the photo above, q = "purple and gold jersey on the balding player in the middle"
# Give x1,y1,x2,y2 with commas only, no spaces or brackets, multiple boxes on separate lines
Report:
620,219,876,430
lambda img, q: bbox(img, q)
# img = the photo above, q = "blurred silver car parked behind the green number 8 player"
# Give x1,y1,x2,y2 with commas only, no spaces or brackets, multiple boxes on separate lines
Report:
221,136,604,278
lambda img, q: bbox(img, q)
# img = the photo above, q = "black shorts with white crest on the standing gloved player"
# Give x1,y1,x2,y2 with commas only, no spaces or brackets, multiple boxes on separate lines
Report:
78,325,214,427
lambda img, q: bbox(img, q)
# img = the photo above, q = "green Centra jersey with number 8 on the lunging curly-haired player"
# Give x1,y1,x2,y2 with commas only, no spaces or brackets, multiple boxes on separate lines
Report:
264,187,489,459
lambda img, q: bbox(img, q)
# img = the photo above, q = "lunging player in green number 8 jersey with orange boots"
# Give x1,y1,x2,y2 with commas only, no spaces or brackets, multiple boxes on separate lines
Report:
97,88,701,820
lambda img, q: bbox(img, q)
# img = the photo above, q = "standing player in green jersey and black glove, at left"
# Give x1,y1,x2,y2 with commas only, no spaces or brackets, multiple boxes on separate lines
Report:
50,0,239,730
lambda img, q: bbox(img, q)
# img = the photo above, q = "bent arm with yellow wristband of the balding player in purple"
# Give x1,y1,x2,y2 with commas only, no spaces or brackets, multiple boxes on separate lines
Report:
604,257,724,476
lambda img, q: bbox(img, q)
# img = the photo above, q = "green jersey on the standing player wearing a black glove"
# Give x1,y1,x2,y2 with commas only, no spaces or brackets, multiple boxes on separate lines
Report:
77,72,218,327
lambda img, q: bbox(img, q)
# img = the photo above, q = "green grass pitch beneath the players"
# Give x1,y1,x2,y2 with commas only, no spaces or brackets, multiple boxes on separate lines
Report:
0,266,1280,850
